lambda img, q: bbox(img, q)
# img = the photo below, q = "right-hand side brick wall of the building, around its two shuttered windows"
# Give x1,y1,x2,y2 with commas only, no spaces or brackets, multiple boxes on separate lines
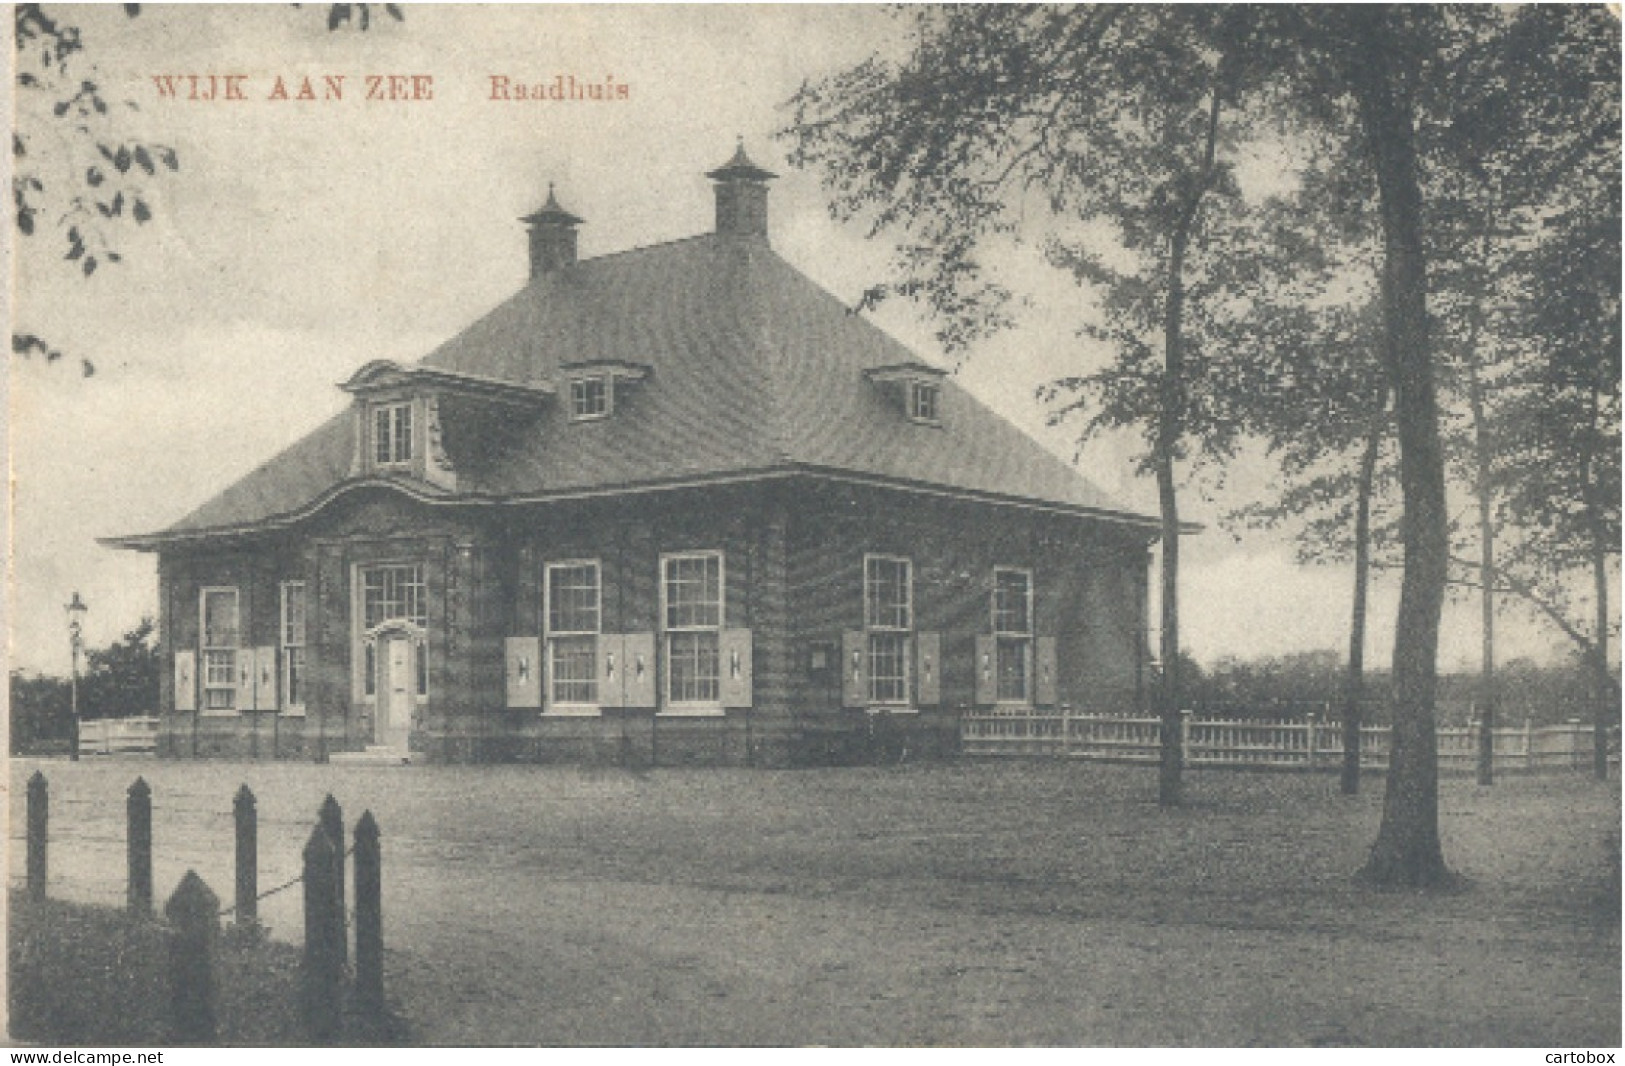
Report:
788,484,1146,757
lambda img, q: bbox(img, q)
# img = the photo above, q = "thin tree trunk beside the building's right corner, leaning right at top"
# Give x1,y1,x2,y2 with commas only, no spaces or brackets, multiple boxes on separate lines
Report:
1155,86,1220,808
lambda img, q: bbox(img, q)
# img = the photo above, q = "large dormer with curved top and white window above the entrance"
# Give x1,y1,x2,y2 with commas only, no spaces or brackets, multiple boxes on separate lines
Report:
340,359,554,491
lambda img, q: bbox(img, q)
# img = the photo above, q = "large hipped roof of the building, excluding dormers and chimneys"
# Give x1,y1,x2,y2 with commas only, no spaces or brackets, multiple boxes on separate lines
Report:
111,234,1155,548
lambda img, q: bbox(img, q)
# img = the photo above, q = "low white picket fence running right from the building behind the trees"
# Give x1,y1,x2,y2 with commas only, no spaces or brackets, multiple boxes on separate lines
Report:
959,707,1619,772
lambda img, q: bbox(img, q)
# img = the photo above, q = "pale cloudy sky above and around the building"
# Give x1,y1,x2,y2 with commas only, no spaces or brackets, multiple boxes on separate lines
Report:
8,5,1599,673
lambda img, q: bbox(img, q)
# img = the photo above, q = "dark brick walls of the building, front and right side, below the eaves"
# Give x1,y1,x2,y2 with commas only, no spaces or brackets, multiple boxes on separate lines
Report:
146,479,1146,765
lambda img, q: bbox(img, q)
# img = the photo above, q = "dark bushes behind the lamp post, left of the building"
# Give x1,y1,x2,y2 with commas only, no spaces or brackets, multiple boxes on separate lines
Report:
11,618,159,756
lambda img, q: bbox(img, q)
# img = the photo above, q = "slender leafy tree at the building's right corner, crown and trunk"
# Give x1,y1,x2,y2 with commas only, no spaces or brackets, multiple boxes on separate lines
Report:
788,7,1300,803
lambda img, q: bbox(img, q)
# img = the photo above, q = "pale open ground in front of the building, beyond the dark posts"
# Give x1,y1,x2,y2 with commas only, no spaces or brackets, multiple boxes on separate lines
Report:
11,759,1620,1048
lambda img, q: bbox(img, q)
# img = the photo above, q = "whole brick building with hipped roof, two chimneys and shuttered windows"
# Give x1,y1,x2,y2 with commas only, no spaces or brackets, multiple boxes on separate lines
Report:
107,150,1157,765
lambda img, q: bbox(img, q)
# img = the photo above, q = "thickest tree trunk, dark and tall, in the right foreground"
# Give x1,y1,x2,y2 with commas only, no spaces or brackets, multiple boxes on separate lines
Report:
1346,5,1451,887
